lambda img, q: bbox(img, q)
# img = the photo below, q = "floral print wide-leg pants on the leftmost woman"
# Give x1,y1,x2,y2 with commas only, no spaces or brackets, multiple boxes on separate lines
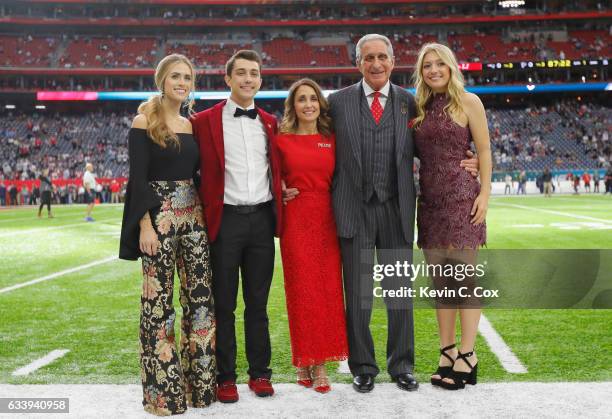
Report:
140,180,216,416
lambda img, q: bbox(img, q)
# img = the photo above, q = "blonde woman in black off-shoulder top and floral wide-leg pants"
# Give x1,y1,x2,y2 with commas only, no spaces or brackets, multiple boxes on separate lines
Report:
119,54,216,415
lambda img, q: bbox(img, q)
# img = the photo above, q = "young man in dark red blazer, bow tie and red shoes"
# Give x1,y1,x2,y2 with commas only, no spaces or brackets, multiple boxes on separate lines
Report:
191,50,282,403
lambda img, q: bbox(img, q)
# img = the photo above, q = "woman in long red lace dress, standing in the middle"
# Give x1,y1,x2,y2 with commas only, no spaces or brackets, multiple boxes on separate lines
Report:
274,79,348,393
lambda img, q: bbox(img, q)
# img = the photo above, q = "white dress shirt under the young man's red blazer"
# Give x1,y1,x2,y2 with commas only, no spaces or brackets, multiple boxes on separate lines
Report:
223,99,272,205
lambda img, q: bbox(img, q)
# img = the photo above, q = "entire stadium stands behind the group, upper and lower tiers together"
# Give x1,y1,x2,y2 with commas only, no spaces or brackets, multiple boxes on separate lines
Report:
0,0,612,184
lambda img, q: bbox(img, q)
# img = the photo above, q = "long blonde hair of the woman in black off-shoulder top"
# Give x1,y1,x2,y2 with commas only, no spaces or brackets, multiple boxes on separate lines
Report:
138,54,195,148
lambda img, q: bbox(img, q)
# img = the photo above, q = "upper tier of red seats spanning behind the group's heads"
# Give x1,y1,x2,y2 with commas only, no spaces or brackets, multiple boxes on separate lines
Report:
0,31,612,68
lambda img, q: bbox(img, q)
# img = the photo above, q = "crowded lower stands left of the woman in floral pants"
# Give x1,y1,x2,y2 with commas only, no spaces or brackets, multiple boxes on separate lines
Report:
0,112,131,180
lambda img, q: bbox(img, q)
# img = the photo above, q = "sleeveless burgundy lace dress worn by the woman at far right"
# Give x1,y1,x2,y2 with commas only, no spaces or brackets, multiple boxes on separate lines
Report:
415,94,486,249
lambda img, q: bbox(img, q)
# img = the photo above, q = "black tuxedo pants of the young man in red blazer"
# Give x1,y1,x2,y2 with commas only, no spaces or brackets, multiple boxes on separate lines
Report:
211,205,275,383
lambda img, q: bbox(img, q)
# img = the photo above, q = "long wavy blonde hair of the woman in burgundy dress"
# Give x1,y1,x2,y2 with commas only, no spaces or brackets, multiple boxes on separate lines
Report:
412,43,465,127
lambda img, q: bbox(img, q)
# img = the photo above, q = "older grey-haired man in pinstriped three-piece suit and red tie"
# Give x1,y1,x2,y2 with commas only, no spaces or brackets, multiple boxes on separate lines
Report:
329,34,418,392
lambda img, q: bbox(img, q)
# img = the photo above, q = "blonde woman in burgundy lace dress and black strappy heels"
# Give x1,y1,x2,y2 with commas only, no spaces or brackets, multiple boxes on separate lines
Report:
413,44,492,390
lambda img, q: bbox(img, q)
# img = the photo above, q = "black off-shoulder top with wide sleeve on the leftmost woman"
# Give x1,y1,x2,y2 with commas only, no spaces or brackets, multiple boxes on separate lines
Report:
119,128,200,260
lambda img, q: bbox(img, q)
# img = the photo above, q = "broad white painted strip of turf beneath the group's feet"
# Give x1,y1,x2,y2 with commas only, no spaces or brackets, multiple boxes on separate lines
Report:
0,384,612,419
